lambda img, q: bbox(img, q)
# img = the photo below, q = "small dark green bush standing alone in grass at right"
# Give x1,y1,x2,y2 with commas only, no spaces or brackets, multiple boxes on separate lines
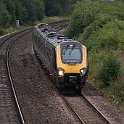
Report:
99,54,120,86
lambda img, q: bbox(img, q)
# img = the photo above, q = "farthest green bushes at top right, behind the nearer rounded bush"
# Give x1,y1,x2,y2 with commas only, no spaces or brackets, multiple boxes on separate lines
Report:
67,0,124,37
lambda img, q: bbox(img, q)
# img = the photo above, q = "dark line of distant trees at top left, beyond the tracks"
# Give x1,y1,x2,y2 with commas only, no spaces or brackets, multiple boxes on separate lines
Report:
0,0,77,27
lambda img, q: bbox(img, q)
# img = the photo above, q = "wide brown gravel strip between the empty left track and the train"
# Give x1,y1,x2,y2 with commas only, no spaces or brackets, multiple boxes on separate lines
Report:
10,33,82,124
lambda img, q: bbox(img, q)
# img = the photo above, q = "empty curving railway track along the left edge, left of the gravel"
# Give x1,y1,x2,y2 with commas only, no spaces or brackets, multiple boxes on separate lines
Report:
0,29,31,124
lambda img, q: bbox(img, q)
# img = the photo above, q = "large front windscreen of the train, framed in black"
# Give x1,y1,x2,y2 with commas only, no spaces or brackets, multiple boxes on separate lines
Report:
62,47,82,64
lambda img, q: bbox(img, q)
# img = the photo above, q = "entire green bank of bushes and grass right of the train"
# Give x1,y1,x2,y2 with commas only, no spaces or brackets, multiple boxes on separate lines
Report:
65,0,124,110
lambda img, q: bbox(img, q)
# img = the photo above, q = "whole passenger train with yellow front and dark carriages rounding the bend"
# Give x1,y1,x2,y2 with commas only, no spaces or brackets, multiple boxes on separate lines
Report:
33,23,88,92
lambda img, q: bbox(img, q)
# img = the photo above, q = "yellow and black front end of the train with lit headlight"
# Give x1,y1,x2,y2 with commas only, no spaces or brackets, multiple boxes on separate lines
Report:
56,42,88,89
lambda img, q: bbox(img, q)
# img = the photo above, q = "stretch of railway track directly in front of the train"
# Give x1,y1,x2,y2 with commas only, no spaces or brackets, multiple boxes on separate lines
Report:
62,95,112,124
